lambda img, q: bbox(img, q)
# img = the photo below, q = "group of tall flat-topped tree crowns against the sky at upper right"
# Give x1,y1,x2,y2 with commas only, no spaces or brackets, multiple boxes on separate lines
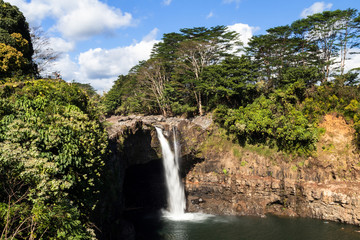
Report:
246,9,360,90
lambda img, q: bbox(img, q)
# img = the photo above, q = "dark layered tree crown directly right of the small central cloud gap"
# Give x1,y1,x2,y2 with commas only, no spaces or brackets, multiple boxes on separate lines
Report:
246,23,319,91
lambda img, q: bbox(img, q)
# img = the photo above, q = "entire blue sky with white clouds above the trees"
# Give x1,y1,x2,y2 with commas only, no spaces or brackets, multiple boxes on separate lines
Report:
5,0,360,92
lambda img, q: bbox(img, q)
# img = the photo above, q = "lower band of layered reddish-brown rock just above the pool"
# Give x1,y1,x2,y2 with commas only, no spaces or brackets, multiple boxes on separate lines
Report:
186,163,360,225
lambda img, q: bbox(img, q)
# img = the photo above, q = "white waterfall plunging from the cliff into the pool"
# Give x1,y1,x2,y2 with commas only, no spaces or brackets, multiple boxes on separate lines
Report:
155,127,186,218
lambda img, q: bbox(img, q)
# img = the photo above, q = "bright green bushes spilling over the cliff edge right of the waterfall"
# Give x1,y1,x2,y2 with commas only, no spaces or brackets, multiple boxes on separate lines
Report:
215,87,319,154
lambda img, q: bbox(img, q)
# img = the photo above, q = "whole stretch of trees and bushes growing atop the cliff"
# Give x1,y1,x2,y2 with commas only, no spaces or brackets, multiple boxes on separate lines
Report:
105,9,360,154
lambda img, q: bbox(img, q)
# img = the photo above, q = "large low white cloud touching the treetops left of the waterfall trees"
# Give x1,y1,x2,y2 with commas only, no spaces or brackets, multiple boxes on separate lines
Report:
53,28,159,92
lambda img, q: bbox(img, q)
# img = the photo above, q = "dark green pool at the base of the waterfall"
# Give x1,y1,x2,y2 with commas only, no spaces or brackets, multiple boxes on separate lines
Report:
131,212,360,240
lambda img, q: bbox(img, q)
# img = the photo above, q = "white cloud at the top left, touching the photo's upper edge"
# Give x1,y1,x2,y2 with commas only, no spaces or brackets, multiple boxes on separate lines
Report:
8,0,133,40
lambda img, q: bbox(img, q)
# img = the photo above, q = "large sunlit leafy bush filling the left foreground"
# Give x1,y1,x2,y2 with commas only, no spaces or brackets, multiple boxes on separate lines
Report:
0,80,107,239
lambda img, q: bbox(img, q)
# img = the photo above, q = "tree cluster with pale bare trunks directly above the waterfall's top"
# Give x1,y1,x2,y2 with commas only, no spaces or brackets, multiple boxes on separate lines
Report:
104,26,243,116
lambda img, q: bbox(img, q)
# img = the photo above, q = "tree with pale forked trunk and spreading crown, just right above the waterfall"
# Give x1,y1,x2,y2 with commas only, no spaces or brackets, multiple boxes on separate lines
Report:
175,26,240,115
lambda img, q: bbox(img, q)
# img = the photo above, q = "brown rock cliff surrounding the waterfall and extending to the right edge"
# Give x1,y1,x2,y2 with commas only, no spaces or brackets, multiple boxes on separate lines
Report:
108,115,360,229
